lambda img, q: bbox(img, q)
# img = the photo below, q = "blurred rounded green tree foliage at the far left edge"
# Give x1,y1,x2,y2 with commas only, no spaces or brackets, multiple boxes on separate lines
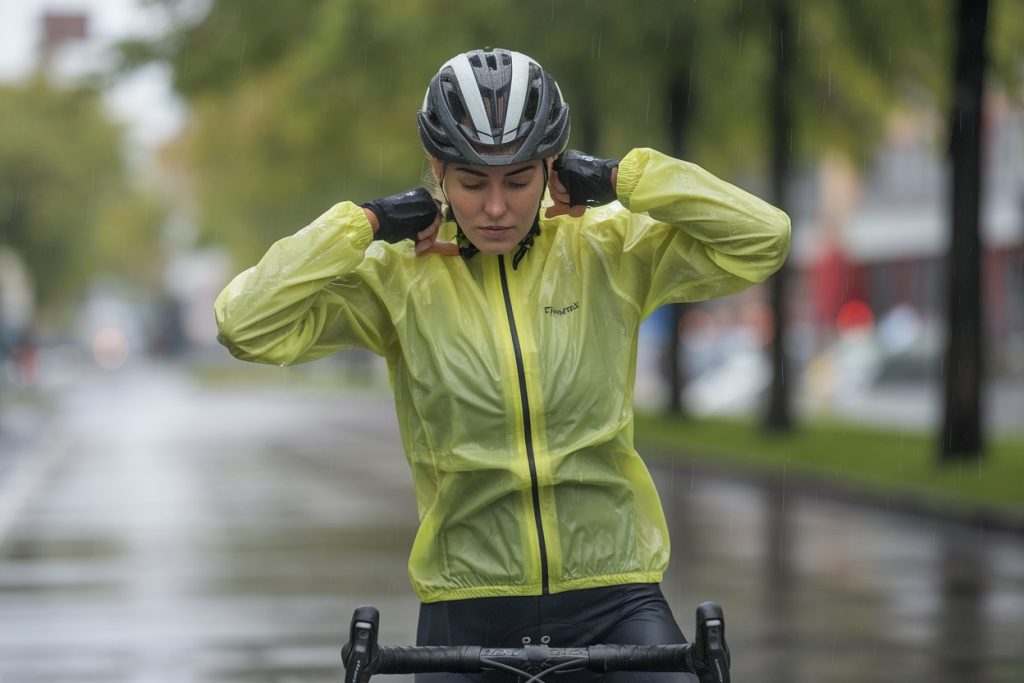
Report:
0,80,139,321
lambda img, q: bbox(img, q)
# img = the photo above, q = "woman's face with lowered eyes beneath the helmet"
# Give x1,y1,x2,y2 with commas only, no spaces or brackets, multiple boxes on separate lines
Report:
431,160,544,254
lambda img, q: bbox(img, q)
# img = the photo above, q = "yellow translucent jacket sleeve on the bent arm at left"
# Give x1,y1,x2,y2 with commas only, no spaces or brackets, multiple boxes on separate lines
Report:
214,202,393,366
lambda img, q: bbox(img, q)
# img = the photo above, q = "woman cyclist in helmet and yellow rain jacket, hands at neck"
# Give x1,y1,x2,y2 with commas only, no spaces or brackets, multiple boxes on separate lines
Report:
216,49,790,680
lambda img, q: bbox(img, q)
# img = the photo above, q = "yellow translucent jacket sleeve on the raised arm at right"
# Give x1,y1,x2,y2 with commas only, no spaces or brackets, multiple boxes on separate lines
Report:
602,148,790,316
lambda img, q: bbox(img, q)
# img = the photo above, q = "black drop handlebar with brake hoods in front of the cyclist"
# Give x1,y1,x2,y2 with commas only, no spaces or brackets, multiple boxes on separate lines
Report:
342,602,729,683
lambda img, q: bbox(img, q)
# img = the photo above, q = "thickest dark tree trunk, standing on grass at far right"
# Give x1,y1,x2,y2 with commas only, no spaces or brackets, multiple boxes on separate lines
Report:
940,0,988,462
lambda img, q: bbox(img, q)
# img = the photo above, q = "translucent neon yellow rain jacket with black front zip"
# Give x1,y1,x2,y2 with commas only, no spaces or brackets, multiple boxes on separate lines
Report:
216,148,790,602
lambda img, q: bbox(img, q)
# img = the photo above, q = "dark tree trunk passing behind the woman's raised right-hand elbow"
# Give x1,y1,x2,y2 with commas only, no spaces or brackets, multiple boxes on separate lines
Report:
763,0,794,432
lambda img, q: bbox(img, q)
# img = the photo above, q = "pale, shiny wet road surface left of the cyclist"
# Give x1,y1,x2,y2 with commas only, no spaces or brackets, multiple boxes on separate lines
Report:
0,368,416,683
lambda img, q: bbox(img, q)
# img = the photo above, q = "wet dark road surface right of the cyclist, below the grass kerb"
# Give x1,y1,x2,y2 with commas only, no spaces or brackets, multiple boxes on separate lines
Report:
656,464,1024,683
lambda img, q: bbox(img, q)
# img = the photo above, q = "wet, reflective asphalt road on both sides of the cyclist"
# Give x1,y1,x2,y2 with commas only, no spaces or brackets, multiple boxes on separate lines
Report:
0,366,1024,683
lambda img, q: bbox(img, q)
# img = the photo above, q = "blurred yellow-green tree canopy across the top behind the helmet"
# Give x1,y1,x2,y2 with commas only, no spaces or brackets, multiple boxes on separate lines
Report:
134,0,1024,272
